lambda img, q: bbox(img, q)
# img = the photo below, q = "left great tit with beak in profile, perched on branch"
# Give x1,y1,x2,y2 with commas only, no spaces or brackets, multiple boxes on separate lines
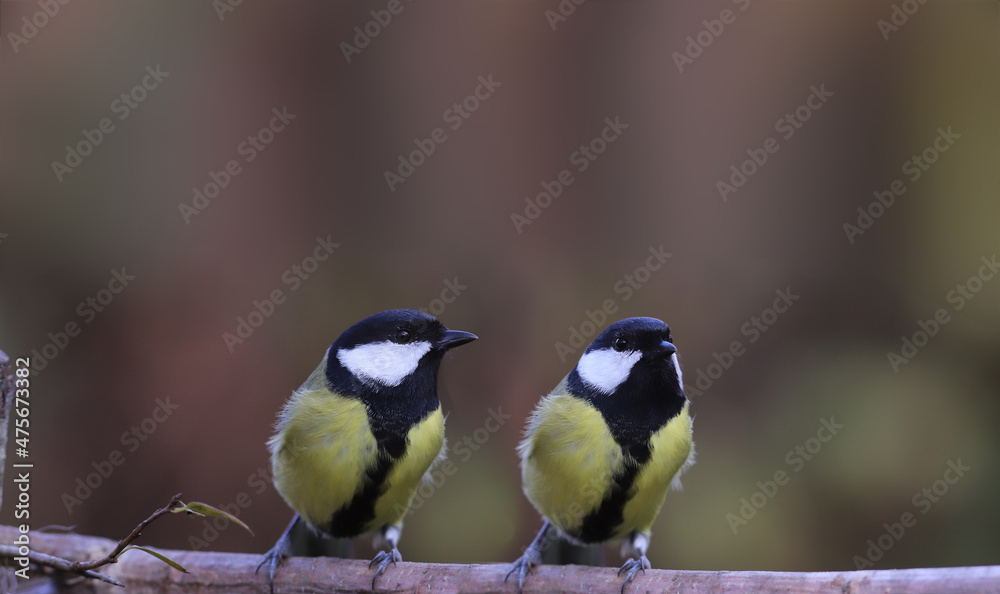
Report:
257,309,476,592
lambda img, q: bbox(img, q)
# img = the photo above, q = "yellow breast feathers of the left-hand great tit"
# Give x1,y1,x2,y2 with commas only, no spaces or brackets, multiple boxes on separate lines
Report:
268,365,444,532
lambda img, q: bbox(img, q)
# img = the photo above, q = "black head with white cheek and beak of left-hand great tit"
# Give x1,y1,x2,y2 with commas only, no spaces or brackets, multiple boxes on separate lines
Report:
326,309,476,395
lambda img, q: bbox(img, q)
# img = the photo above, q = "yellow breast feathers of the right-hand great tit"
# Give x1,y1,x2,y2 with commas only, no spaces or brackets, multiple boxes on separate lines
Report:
520,384,691,538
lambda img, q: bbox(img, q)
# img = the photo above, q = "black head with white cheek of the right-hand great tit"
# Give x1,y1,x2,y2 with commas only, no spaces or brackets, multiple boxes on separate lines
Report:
570,318,684,399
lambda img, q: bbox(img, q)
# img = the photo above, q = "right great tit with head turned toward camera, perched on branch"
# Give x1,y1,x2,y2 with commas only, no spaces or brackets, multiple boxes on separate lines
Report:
505,318,694,594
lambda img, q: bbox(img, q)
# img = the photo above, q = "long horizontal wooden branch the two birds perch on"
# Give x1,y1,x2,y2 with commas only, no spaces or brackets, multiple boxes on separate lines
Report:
0,526,1000,594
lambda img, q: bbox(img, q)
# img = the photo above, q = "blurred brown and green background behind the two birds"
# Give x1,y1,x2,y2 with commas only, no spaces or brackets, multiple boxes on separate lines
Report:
0,0,1000,570
